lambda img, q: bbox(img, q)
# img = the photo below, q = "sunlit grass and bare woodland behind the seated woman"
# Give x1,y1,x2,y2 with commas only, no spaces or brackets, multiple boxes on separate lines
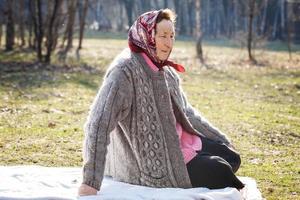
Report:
0,0,300,200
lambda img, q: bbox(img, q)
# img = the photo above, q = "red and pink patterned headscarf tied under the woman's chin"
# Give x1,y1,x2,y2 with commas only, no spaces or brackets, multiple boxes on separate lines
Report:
128,10,185,72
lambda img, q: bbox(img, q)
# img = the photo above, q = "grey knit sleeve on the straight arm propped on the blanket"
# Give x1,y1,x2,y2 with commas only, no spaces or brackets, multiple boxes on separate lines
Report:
82,69,132,190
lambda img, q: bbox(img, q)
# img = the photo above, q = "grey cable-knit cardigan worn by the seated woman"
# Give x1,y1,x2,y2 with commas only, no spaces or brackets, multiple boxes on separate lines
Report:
83,49,229,190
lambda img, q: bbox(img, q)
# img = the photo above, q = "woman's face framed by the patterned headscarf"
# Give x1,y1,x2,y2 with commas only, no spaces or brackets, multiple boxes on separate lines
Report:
155,19,175,61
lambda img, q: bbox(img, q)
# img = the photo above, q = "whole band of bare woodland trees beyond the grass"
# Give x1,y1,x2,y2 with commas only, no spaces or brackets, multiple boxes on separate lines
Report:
0,0,300,62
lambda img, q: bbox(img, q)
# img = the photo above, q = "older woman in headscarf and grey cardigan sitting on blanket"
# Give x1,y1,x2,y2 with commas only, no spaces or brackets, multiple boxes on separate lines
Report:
78,9,244,196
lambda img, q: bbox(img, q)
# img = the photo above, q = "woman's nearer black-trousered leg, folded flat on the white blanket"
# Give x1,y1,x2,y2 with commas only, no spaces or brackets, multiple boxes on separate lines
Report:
187,152,244,189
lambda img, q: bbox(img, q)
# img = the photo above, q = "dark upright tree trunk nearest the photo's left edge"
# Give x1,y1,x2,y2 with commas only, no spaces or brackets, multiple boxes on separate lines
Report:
5,0,15,51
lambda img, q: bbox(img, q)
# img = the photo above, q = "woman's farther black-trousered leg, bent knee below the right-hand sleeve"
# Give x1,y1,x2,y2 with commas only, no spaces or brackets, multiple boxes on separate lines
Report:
200,137,241,173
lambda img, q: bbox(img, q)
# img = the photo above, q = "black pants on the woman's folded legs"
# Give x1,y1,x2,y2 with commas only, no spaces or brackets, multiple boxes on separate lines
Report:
187,137,244,189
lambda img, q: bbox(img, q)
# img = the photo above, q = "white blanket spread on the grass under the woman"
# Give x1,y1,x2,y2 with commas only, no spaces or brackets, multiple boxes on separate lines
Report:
0,166,262,200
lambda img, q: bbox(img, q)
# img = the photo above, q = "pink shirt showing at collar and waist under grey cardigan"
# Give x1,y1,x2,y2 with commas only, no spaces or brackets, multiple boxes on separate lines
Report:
141,53,202,164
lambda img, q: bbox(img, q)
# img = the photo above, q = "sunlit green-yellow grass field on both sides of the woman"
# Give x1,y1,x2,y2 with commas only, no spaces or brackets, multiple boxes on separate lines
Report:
0,36,300,200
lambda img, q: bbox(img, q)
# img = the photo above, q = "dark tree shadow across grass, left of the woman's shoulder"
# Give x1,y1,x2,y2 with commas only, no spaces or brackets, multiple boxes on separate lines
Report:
0,62,104,91
